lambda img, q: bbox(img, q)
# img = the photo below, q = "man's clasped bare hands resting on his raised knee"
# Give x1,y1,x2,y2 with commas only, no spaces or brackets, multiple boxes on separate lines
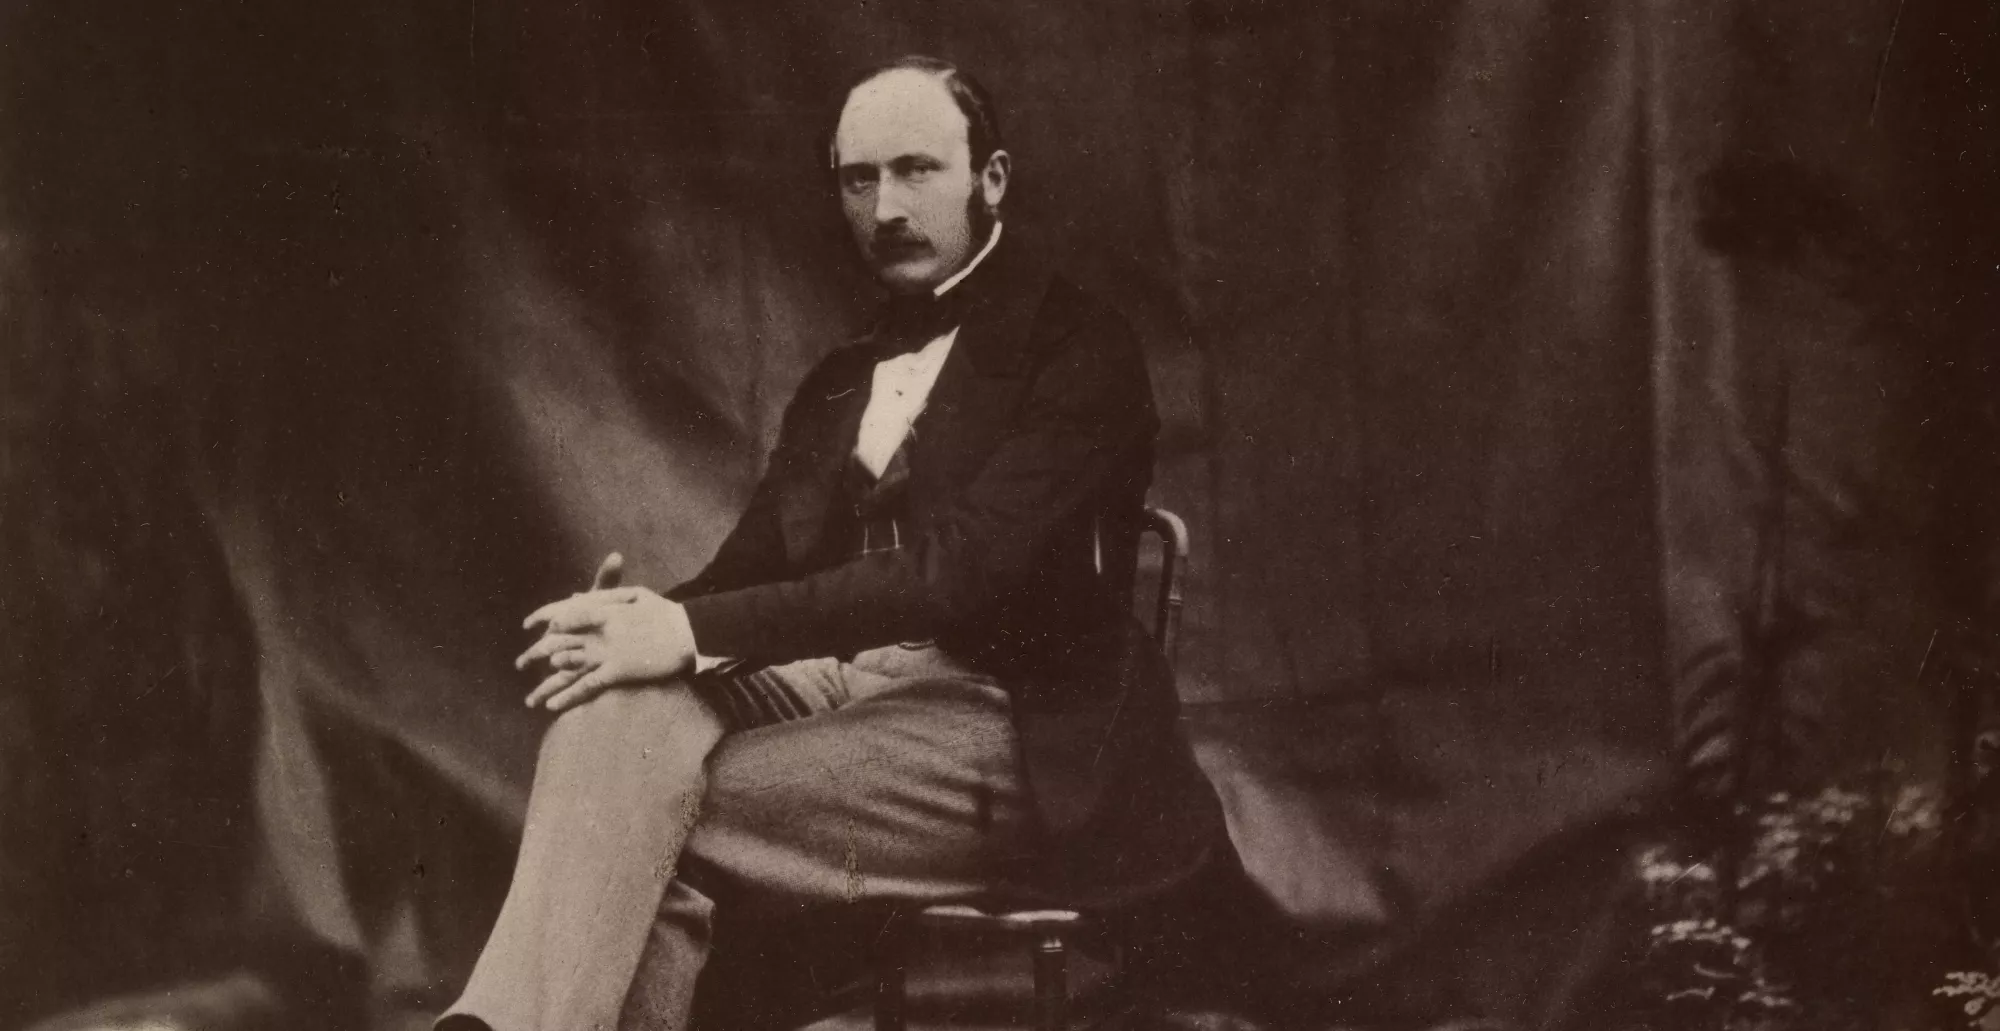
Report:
514,551,694,713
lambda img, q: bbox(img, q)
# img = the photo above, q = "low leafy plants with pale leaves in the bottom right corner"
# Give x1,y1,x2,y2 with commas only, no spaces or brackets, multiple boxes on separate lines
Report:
1632,769,2000,1031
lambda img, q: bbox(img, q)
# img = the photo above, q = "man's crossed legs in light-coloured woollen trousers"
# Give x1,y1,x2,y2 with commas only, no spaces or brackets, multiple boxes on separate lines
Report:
440,649,1030,1031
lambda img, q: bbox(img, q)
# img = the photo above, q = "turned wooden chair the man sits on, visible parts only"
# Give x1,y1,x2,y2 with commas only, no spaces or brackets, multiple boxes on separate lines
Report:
874,508,1188,1031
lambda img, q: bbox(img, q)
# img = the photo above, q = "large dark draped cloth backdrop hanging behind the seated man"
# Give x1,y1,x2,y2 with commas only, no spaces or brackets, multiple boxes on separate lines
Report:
0,0,2000,1013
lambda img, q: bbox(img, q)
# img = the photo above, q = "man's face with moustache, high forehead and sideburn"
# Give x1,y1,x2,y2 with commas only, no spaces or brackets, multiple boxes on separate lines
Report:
834,70,1008,294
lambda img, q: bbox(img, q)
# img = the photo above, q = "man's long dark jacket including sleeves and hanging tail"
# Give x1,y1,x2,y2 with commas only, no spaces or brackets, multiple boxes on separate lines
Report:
670,234,1224,905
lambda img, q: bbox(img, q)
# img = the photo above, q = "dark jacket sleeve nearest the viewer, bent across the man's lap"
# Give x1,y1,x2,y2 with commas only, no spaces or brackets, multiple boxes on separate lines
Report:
688,316,1156,663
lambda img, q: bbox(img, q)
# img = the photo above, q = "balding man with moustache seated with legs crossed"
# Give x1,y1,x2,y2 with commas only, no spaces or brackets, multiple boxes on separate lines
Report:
444,58,1226,1031
